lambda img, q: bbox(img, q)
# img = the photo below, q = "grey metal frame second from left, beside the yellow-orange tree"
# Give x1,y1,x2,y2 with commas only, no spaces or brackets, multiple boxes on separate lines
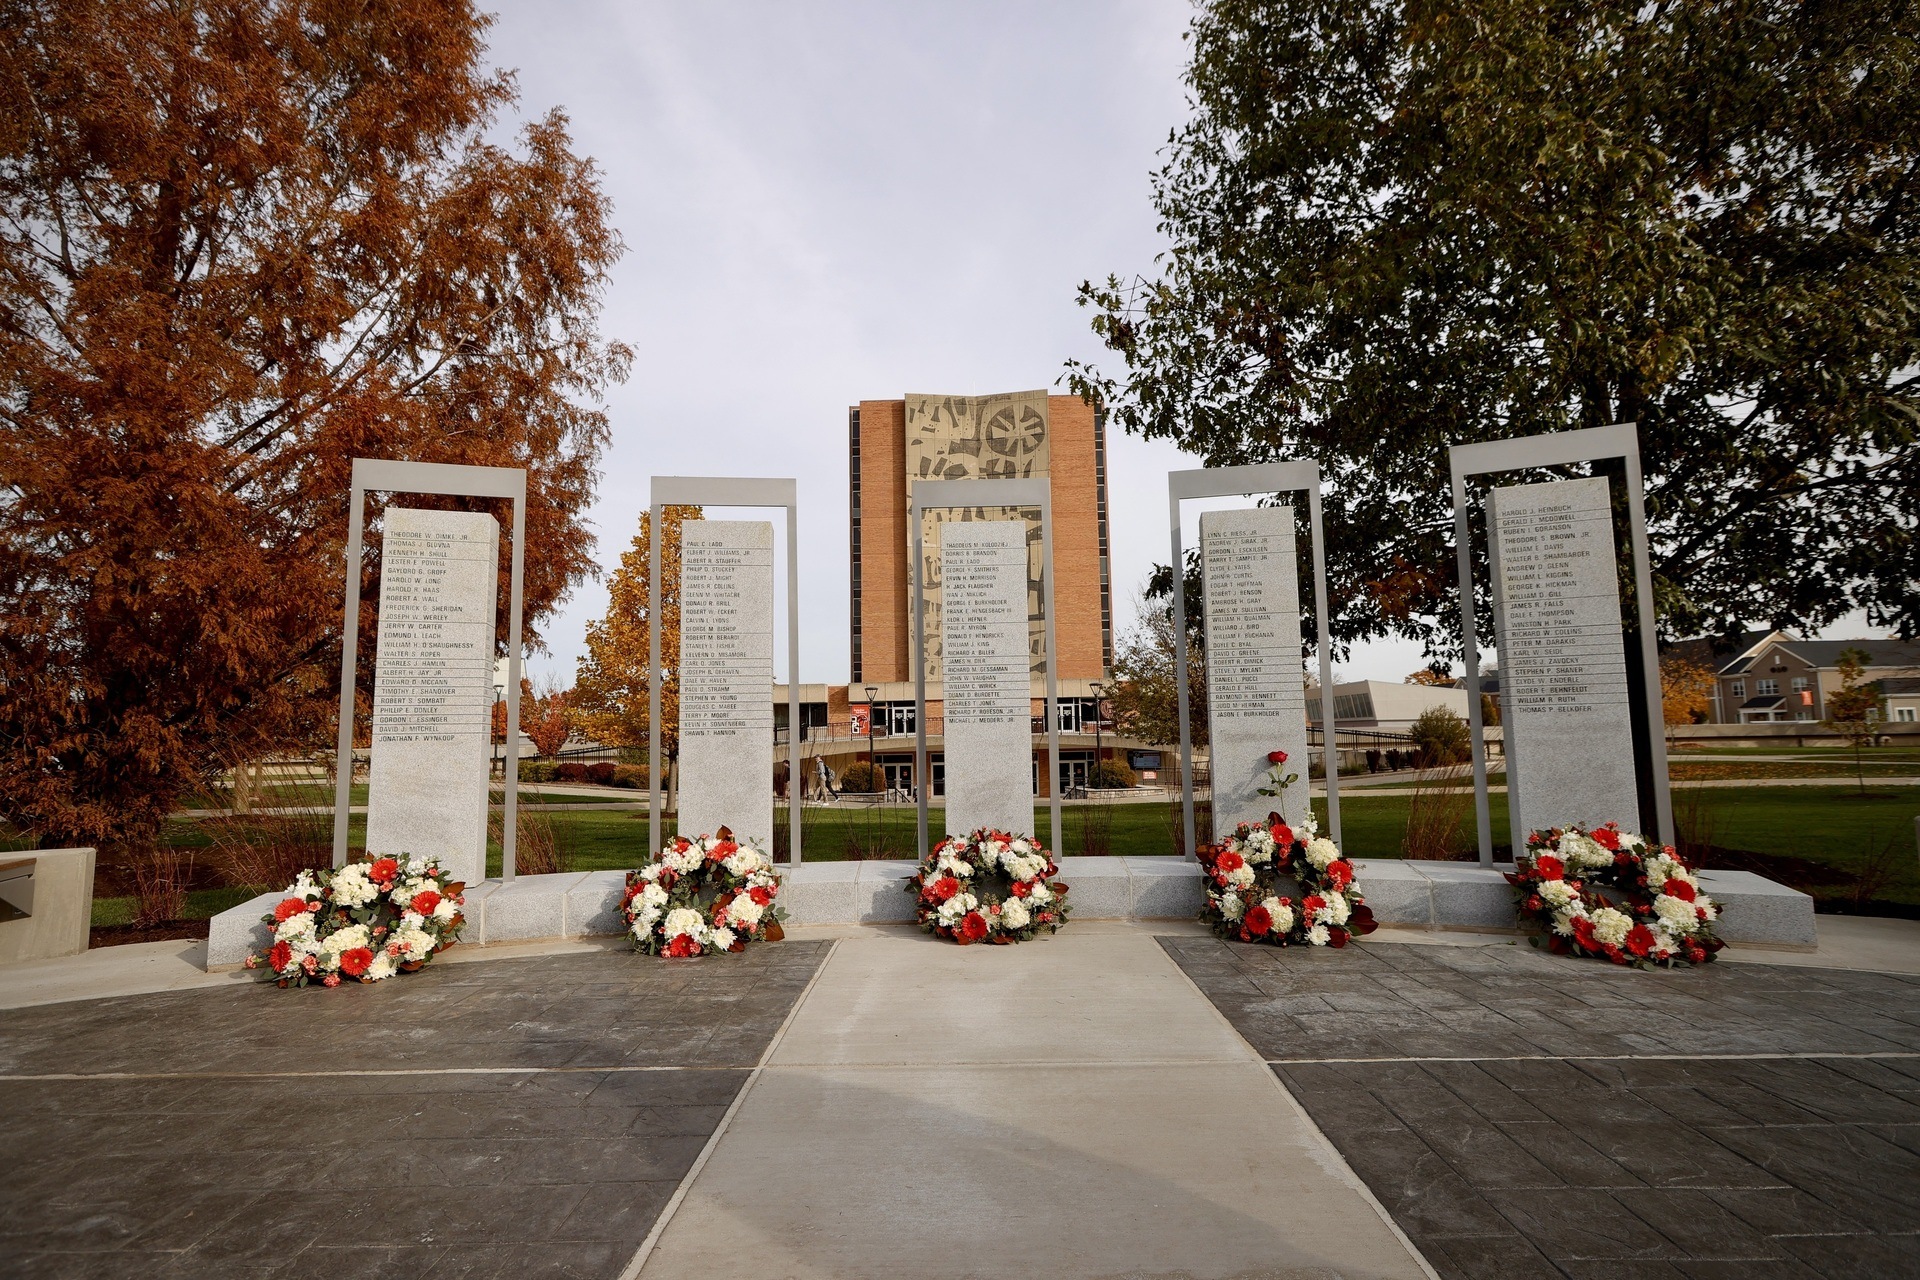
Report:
647,476,806,867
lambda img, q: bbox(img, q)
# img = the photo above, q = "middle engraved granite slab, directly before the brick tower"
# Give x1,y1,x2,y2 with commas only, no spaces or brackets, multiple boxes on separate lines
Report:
939,520,1033,835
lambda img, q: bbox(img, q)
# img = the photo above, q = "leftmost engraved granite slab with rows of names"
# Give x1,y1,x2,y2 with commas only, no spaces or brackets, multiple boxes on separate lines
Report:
367,507,499,885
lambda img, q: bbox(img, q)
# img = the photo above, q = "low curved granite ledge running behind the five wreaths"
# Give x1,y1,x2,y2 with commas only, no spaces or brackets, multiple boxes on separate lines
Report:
207,858,1818,971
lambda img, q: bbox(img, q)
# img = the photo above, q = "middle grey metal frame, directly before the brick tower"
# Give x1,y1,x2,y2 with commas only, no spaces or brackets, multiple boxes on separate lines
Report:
902,480,1059,862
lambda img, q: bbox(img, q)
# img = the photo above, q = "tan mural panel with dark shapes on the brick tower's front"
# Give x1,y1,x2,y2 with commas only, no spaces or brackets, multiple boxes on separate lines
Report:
904,390,1050,681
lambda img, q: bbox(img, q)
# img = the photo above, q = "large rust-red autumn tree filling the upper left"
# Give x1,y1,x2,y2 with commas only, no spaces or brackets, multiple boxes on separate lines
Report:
0,0,630,915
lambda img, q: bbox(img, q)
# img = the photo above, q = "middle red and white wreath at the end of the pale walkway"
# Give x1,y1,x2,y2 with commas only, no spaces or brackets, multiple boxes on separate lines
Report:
906,827,1068,946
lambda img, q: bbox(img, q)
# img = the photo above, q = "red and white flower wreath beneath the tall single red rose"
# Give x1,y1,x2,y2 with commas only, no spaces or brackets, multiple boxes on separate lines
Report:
1198,814,1379,946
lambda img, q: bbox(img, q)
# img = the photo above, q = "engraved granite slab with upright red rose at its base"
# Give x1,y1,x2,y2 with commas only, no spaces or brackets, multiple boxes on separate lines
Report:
1200,507,1308,835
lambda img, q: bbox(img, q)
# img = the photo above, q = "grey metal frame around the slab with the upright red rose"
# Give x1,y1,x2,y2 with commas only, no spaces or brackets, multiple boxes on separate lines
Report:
1167,461,1340,852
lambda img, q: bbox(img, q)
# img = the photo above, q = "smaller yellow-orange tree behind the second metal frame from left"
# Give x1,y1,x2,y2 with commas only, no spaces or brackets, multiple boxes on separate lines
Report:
574,507,701,756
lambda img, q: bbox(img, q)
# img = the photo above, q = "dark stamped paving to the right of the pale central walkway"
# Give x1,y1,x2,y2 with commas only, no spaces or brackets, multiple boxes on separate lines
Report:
1162,936,1920,1280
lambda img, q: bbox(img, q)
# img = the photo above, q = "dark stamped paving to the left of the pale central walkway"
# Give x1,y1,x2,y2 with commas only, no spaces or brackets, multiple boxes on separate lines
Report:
0,942,828,1280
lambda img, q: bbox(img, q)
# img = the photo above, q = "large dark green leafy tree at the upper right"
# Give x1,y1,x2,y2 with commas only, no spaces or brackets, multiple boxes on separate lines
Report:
1068,0,1920,654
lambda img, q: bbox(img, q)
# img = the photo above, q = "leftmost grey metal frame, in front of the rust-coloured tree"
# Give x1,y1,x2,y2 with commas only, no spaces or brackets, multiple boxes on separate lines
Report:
334,459,526,881
